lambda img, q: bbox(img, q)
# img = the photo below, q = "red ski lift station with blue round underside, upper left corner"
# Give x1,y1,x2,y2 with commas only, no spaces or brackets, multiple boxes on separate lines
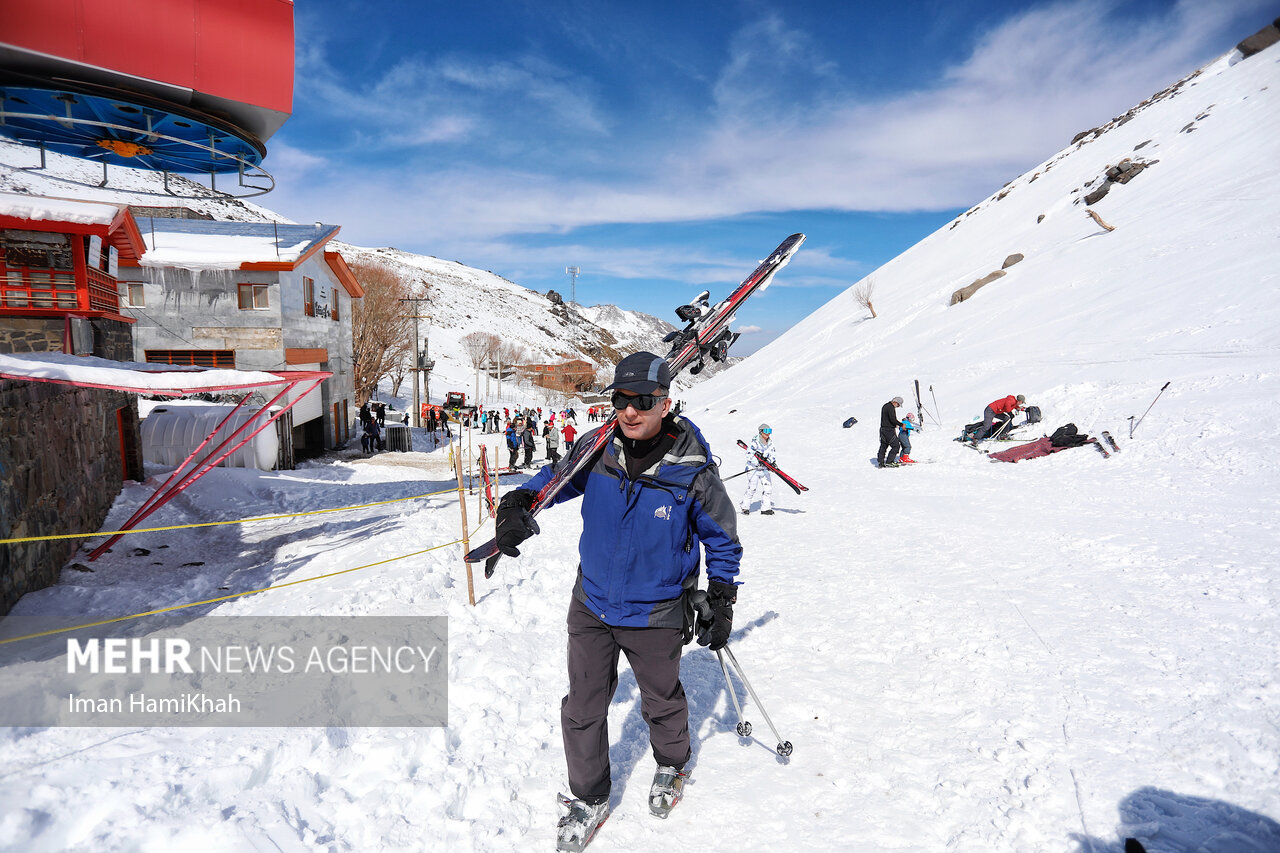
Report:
0,0,293,197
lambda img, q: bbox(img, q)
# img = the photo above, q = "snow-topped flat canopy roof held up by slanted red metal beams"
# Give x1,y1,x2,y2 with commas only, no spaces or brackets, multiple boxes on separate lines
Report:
0,352,333,397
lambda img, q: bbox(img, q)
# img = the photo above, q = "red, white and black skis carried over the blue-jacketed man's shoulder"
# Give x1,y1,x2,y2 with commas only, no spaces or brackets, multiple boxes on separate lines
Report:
465,234,805,578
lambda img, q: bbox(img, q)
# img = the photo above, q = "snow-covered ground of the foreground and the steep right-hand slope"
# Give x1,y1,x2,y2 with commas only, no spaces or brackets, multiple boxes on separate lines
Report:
0,34,1280,853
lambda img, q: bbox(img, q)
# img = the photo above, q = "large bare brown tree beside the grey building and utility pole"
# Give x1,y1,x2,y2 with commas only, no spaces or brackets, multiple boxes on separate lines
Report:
351,261,413,402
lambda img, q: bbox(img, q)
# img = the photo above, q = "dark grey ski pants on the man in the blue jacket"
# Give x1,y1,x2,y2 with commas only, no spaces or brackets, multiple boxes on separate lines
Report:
561,598,691,803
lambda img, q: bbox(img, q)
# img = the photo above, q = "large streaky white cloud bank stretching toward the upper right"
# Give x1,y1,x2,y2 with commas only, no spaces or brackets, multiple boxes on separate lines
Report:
270,0,1258,245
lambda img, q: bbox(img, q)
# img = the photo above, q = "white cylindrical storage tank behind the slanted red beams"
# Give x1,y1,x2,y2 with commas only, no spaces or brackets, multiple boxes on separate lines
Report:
142,403,280,471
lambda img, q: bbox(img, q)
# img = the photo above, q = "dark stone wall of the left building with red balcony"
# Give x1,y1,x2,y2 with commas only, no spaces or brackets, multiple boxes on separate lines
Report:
0,318,142,616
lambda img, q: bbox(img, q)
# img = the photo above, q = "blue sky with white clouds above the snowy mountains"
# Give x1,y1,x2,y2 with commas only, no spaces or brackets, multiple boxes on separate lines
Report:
261,0,1274,355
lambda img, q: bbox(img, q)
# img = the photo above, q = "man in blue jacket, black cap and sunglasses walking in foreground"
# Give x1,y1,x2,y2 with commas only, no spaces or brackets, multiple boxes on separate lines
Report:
495,352,742,850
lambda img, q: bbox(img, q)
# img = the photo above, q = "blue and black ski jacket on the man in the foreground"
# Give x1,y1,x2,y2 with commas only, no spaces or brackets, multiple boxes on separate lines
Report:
522,416,742,628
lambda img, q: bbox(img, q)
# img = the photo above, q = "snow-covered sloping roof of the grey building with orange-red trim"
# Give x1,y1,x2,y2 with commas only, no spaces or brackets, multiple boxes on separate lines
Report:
137,216,339,269
